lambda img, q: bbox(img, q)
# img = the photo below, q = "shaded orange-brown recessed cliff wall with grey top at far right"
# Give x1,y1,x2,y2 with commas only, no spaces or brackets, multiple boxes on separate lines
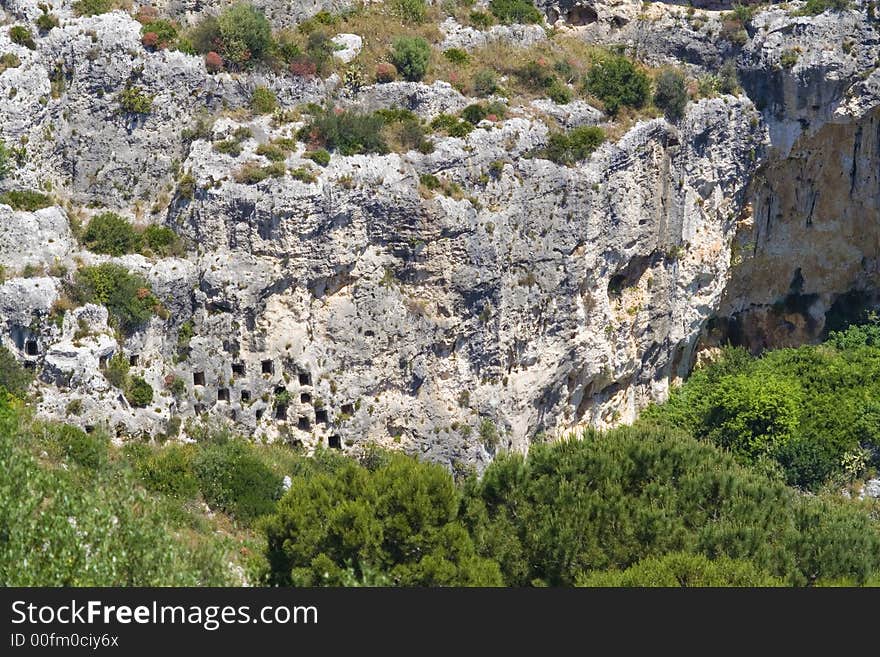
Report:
708,10,880,352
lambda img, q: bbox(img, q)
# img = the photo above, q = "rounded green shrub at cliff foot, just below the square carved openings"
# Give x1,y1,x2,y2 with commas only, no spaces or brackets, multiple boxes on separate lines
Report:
193,440,281,522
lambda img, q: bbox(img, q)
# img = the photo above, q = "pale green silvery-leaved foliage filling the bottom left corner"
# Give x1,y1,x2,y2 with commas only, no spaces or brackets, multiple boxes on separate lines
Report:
0,394,229,586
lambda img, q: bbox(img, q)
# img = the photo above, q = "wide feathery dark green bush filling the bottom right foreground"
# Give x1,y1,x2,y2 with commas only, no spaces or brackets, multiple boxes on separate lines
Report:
465,428,880,585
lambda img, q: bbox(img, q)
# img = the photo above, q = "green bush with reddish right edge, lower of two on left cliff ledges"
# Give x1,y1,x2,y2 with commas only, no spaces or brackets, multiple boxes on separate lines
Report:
70,262,160,333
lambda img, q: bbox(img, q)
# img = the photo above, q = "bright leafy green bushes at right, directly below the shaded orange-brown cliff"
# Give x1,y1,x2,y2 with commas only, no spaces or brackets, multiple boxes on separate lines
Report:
642,325,880,490
